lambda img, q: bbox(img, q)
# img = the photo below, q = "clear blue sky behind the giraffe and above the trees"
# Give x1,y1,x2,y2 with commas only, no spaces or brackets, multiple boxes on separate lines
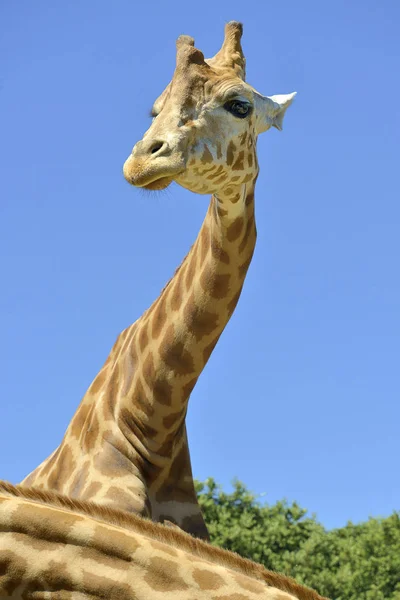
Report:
0,0,400,527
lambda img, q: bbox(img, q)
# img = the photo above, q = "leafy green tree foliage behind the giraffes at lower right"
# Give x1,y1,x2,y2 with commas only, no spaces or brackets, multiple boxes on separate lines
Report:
197,479,400,600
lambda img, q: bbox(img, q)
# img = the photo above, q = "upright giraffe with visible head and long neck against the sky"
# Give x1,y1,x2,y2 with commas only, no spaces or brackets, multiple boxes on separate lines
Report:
23,21,295,539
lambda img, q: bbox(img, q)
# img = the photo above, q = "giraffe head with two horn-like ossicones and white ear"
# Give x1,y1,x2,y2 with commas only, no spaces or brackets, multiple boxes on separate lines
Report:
124,21,295,195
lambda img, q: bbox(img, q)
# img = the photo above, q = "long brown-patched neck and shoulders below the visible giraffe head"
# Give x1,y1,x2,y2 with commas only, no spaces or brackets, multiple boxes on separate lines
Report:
24,179,256,537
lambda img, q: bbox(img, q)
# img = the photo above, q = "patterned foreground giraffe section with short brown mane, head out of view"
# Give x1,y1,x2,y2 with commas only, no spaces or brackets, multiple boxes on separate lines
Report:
0,482,324,600
